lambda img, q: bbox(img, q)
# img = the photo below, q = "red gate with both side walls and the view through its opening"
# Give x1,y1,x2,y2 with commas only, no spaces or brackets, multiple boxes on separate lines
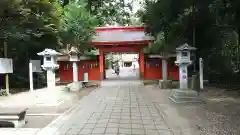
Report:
59,26,179,83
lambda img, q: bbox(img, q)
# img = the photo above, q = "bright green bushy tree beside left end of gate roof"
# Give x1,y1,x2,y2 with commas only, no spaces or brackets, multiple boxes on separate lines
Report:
60,1,99,51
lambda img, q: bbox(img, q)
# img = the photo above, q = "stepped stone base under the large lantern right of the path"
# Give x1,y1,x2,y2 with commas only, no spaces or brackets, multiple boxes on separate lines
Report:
169,89,202,103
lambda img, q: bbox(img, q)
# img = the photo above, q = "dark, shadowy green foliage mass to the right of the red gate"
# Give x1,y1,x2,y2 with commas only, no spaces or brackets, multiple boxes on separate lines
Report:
139,0,240,89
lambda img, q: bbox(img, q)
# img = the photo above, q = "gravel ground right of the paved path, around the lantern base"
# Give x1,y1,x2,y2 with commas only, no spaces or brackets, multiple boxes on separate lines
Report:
145,88,240,135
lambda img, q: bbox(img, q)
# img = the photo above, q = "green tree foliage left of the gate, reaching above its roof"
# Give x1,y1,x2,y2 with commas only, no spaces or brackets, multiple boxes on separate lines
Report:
0,0,131,87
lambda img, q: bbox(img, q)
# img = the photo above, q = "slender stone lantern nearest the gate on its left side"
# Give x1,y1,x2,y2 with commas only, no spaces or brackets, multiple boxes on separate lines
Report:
68,47,80,82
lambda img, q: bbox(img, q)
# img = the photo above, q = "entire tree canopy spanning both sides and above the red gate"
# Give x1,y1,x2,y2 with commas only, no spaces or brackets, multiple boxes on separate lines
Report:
0,0,240,89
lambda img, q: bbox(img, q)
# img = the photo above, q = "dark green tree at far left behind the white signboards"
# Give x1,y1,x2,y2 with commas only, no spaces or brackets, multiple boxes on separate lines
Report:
0,0,61,87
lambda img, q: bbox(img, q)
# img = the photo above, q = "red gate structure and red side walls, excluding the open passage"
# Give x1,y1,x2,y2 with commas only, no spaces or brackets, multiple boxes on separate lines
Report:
59,26,178,82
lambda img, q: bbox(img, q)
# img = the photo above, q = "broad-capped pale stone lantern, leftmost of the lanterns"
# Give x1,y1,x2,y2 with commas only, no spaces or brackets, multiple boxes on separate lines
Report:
37,49,62,88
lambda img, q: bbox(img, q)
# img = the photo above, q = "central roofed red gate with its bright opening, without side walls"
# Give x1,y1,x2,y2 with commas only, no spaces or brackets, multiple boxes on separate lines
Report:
91,26,152,80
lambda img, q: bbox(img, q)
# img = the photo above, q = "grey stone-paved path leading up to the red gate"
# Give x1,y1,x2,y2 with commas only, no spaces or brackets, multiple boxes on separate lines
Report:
37,81,173,135
